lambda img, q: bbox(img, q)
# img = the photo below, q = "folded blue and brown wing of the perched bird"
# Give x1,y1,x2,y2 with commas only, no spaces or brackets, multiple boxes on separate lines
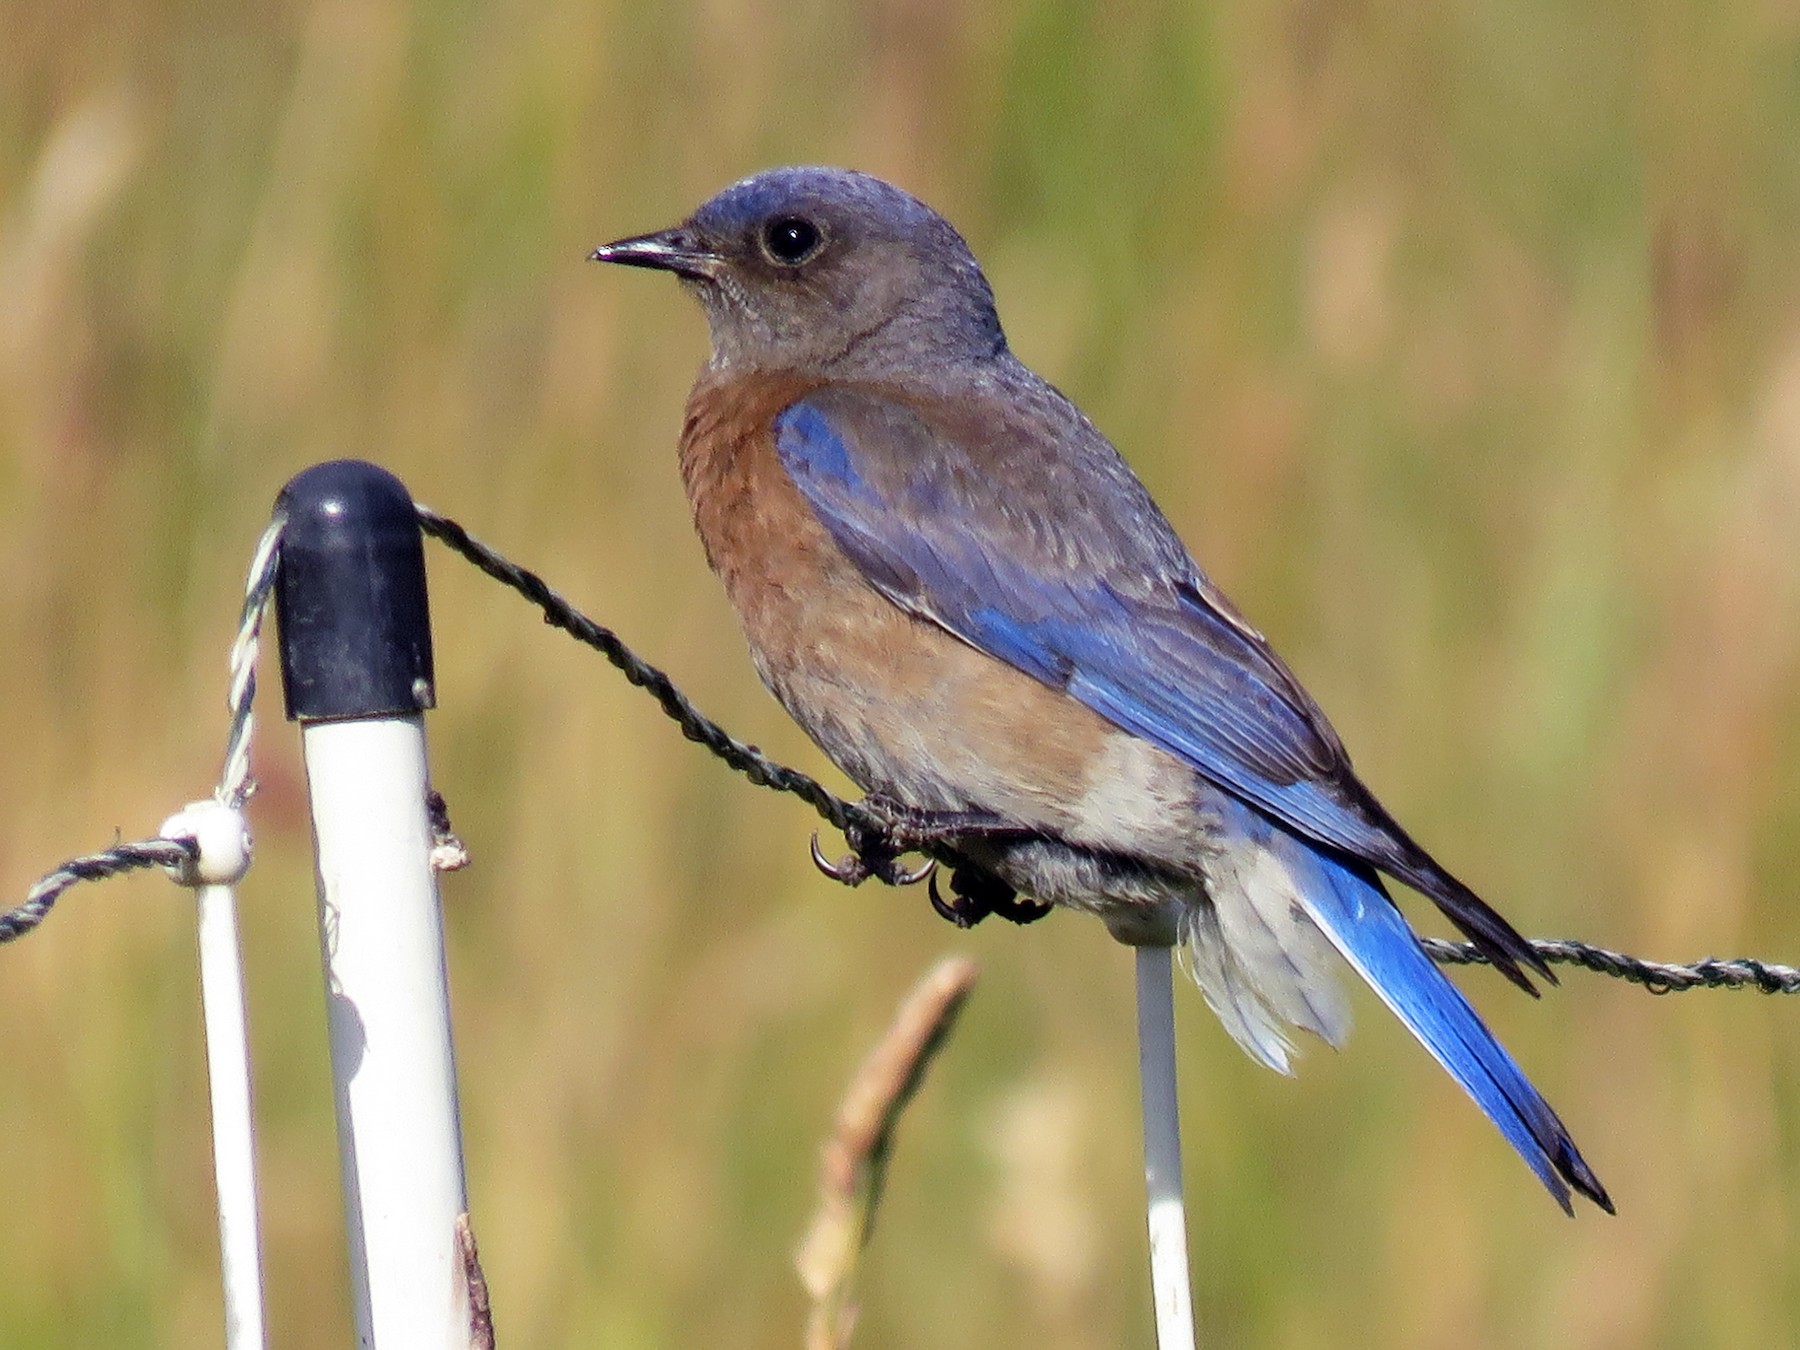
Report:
776,385,1548,988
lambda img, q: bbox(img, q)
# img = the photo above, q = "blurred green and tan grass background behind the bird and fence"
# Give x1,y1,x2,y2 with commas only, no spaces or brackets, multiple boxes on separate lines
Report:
0,0,1800,1350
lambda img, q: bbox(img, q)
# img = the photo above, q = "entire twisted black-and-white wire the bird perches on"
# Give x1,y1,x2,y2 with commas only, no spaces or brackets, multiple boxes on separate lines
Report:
10,502,1800,994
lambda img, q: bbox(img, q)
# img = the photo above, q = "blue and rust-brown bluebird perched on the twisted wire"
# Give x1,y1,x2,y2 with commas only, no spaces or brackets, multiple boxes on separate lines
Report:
594,167,1613,1211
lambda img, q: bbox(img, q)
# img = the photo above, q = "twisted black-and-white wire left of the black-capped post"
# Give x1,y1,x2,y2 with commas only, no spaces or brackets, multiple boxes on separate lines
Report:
0,513,286,945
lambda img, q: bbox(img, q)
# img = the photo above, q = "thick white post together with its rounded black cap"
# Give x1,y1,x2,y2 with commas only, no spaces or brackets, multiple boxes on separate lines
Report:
275,461,470,1350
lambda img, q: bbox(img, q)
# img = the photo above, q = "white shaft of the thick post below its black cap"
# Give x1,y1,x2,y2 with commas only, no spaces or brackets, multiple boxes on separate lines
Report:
302,715,468,1350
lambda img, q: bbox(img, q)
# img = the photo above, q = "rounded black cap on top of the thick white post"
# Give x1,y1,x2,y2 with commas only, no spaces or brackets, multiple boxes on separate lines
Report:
275,459,437,722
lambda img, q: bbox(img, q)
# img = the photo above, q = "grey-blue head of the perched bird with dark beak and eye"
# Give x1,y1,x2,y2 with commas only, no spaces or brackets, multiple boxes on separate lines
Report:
592,167,1006,374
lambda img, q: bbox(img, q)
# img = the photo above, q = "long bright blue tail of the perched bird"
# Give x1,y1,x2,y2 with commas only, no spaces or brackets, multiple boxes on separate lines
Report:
1269,830,1613,1213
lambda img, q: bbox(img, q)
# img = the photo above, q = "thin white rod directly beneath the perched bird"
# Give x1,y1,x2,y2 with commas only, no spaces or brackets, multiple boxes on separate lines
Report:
1136,947,1193,1350
